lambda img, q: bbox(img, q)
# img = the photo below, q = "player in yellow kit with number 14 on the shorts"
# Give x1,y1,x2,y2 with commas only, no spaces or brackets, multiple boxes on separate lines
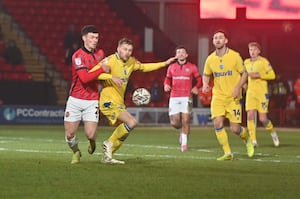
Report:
202,30,254,161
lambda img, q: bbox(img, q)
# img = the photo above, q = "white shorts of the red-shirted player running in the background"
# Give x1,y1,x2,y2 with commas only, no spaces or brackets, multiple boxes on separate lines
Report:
169,97,192,115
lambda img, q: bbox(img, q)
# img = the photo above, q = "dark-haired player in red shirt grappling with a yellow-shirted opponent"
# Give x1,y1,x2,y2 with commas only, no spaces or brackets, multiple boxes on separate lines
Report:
64,25,109,164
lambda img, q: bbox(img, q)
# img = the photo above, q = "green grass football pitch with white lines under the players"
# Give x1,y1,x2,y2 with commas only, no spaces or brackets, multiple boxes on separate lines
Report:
0,125,300,199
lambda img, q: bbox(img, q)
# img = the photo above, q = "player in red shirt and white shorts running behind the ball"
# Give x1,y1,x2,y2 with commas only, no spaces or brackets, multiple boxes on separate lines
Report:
164,46,202,152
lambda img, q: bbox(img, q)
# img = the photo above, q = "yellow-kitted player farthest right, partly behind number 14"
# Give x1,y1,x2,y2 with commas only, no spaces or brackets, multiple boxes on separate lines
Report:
244,42,279,146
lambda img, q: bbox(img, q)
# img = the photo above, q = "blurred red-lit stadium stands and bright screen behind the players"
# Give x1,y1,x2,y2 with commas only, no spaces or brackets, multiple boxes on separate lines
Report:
0,0,300,126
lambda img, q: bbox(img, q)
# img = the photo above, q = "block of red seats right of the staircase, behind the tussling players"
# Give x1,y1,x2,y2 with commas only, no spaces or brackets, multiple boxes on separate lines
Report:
0,0,148,86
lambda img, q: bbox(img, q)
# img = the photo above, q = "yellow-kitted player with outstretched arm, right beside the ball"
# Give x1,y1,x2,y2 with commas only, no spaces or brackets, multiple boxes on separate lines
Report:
90,38,177,164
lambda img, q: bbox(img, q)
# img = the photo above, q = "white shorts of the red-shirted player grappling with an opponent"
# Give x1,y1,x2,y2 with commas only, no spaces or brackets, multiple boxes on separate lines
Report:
64,96,99,122
